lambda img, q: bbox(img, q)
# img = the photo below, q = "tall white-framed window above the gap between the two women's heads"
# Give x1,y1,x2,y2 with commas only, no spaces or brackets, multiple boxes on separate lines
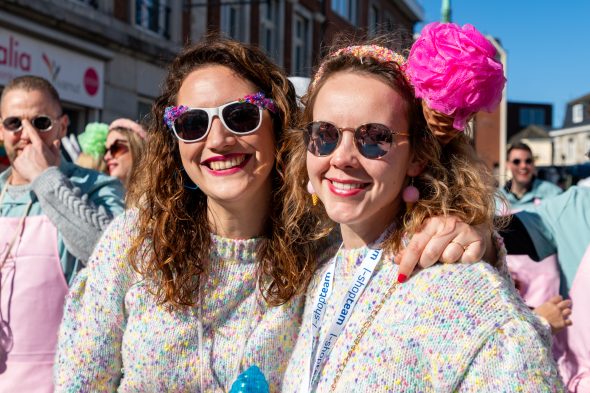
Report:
291,4,313,76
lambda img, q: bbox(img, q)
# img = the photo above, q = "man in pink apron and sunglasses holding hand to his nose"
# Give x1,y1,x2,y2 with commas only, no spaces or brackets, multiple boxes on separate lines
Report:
0,76,123,392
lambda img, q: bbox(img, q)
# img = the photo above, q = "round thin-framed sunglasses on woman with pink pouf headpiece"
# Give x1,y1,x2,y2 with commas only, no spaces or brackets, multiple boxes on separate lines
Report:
304,121,410,159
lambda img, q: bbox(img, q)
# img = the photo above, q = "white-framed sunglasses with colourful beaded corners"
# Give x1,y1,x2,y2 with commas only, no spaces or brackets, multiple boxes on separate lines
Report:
164,92,276,142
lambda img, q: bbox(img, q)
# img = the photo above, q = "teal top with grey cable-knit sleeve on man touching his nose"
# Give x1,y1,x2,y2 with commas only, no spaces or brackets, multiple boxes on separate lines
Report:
0,159,124,282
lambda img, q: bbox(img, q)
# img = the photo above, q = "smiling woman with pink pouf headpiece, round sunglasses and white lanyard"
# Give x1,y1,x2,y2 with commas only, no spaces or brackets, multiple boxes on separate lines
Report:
283,23,561,392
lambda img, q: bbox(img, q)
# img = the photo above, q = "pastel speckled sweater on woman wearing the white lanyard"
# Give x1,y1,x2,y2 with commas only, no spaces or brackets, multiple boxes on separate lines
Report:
283,248,563,393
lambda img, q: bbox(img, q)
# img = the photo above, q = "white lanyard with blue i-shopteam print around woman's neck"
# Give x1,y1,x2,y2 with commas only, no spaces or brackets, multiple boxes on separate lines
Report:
301,240,388,392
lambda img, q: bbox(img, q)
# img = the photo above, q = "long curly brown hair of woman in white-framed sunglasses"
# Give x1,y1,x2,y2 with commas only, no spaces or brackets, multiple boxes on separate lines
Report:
128,36,314,307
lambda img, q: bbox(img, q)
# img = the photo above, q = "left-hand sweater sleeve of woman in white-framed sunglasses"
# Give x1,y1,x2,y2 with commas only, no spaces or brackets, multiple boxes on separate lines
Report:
54,214,133,392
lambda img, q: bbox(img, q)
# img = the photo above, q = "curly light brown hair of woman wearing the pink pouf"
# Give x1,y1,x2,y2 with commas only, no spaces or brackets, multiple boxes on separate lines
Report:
283,37,495,252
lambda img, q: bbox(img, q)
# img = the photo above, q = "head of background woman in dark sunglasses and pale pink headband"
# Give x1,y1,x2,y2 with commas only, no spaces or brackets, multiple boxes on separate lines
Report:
104,118,146,188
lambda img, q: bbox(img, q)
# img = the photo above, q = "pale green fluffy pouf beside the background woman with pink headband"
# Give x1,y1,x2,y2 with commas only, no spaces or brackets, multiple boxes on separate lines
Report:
75,122,109,173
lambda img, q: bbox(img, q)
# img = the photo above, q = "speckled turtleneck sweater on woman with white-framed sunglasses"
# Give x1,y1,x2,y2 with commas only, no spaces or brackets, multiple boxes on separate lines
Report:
55,212,303,392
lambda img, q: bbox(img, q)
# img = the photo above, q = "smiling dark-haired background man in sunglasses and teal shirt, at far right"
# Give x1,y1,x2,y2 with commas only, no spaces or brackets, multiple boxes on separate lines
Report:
500,142,562,212
